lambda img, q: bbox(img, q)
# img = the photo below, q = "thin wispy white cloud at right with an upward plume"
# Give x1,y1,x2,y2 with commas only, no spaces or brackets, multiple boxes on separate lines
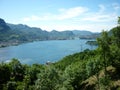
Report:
82,4,117,23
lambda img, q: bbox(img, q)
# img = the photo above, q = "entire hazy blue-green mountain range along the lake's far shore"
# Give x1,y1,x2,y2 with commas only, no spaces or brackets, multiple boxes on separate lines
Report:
0,19,98,46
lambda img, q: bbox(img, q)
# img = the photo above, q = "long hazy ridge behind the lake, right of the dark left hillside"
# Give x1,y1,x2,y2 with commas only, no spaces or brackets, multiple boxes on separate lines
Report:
8,24,74,40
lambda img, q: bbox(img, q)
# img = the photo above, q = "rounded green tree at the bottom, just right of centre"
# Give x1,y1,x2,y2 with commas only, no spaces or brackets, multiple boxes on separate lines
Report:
64,62,87,90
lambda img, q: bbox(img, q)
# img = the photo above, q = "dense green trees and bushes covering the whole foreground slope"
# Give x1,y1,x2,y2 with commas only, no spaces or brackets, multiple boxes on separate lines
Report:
0,17,120,90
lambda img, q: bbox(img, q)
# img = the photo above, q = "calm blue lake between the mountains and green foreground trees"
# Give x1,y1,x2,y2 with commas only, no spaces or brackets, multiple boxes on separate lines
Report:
0,39,96,64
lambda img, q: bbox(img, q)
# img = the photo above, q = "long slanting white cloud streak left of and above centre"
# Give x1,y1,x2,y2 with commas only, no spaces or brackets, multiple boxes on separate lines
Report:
22,7,88,22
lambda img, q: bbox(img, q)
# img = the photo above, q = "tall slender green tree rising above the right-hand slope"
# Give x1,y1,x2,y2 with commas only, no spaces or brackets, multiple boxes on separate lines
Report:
97,31,111,73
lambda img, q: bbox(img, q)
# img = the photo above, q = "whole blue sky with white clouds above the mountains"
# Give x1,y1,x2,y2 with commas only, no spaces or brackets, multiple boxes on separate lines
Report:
0,0,120,32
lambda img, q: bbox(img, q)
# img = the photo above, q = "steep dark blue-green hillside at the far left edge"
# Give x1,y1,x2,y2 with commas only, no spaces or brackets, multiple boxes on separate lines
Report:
0,19,22,47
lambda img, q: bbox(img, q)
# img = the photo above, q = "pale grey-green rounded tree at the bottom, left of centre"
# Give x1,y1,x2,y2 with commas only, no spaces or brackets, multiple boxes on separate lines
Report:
35,65,59,90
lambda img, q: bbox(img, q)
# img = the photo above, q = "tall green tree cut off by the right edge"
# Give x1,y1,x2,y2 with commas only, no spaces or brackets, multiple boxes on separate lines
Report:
110,17,120,68
